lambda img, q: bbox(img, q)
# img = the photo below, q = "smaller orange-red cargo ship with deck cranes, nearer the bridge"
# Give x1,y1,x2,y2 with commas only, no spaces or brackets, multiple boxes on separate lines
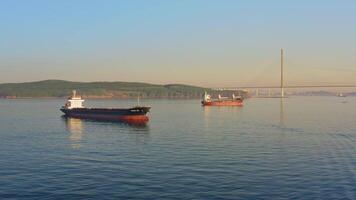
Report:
201,92,243,106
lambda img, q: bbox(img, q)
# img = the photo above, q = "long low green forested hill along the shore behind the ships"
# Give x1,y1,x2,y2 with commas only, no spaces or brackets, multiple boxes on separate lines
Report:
0,80,209,98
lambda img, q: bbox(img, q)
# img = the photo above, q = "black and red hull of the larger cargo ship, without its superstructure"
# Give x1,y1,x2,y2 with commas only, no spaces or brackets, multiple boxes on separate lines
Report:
61,107,150,123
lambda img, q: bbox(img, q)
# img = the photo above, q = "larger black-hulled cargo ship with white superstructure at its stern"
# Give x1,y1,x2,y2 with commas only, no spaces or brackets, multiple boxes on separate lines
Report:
60,90,150,123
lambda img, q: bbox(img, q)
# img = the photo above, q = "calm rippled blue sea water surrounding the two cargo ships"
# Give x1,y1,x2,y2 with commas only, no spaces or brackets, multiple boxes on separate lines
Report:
0,97,356,199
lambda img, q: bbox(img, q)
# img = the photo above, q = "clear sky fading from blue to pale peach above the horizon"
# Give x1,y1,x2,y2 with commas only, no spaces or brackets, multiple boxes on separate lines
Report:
0,0,356,87
